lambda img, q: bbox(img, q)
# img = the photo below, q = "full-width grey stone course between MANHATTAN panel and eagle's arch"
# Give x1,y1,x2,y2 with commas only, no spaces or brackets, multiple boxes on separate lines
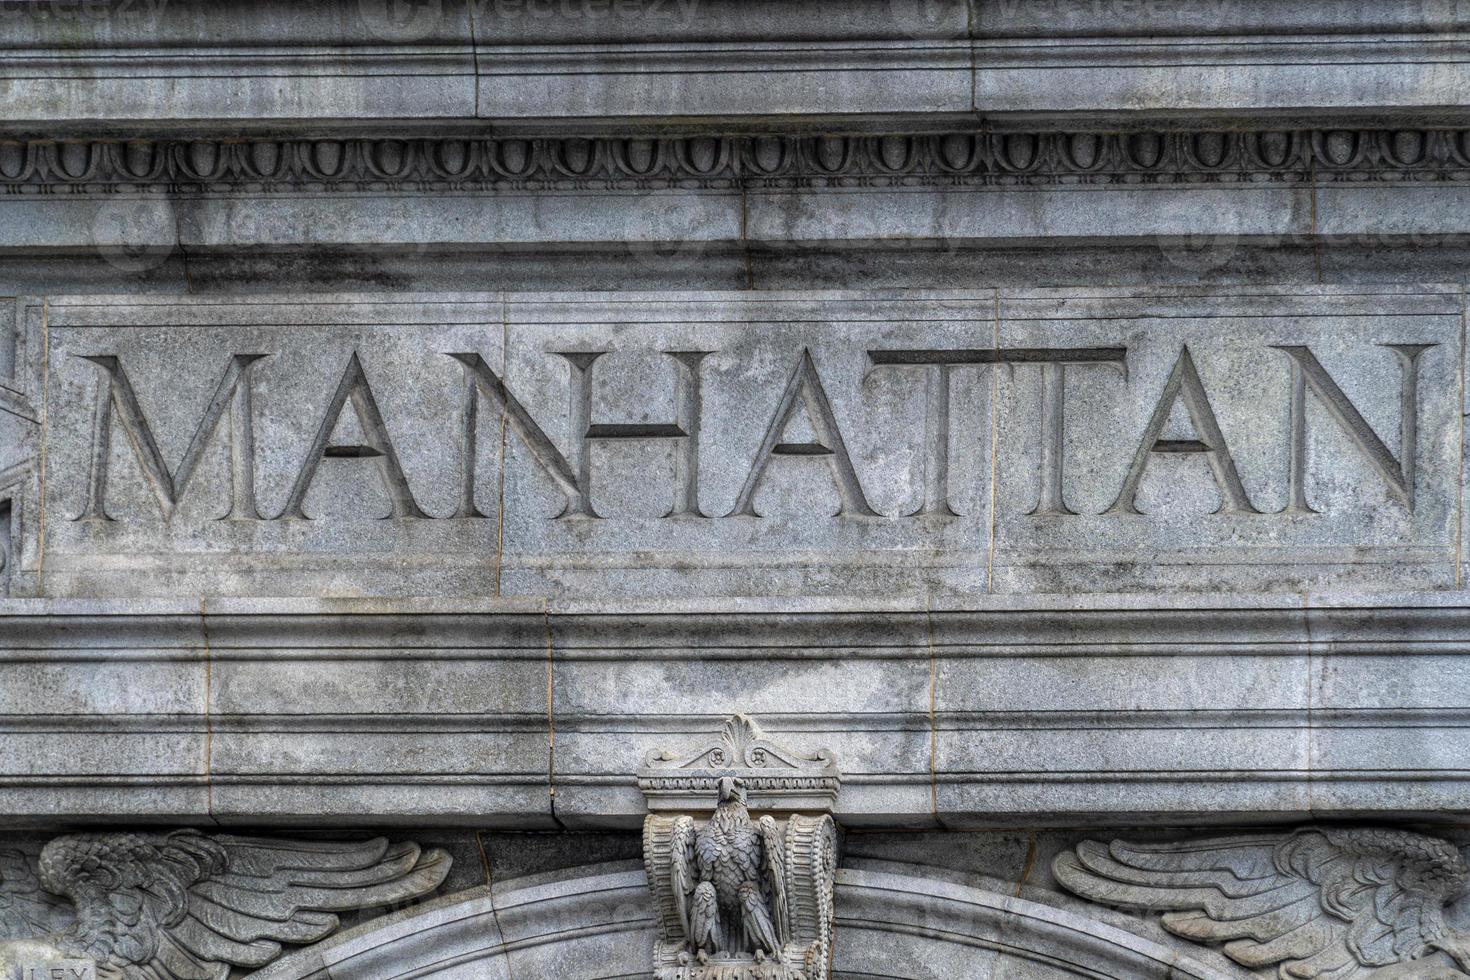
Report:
0,594,1470,829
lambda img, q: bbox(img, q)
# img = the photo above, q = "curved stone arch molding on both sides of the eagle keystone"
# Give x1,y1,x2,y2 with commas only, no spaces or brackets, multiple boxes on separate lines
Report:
251,862,1247,980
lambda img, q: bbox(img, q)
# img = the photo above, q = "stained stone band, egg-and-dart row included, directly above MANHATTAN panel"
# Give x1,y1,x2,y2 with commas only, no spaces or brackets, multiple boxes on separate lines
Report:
0,125,1470,294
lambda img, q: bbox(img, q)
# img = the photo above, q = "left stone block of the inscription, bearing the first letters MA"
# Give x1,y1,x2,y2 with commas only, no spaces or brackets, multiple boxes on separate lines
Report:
37,297,501,597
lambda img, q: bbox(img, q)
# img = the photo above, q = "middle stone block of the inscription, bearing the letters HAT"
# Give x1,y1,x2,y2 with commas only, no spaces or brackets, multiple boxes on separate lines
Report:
501,294,989,598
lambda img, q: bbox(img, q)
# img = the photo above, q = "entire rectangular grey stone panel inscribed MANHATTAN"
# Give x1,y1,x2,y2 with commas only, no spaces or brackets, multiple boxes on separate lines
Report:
12,287,1464,598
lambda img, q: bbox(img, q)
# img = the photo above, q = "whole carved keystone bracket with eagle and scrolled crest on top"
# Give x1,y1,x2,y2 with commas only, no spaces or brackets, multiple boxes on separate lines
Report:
638,716,839,980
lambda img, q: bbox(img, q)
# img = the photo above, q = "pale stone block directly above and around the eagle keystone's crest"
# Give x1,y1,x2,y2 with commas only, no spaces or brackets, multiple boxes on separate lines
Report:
551,614,931,826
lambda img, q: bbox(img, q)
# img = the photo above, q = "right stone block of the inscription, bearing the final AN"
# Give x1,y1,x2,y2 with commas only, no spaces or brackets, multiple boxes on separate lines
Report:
994,287,1460,592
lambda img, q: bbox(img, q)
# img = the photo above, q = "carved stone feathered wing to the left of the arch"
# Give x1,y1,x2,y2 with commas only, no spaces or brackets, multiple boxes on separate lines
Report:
0,830,450,980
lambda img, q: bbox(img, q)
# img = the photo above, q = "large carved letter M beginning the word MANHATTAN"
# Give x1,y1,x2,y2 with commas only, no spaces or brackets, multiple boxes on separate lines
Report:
75,354,266,522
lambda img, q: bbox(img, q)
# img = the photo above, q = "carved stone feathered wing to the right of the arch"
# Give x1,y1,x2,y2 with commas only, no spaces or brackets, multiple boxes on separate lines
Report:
1053,827,1470,980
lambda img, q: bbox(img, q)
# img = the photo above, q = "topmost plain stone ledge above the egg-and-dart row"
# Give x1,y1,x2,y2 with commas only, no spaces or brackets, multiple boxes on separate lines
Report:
0,0,1470,125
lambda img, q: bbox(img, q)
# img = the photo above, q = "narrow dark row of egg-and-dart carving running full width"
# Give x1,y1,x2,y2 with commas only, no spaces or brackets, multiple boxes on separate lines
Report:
0,129,1470,197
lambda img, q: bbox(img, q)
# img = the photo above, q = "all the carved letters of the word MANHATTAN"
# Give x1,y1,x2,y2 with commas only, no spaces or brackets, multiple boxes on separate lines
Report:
76,344,1435,522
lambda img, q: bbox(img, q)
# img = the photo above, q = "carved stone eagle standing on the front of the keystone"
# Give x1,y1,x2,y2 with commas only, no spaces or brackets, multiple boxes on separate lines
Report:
672,776,788,962
